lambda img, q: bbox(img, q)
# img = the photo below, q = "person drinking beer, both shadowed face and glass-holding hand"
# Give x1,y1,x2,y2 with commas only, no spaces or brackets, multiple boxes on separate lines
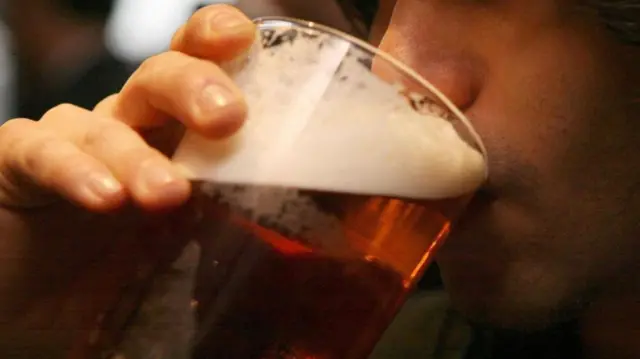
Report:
0,0,640,359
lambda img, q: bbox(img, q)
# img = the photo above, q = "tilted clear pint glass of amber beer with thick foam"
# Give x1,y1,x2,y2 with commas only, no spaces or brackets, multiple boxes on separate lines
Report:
101,18,486,359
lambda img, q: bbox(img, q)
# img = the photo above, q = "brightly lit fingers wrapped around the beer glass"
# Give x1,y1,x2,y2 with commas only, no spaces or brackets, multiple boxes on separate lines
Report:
0,5,255,211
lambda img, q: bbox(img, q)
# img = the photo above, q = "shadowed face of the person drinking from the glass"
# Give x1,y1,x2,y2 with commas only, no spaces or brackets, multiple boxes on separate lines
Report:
373,0,640,328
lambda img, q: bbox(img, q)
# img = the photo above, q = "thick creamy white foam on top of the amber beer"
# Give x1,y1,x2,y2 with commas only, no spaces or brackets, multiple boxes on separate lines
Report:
174,26,485,199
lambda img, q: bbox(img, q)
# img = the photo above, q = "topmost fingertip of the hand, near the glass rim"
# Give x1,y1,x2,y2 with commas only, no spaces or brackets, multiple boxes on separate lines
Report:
171,4,256,62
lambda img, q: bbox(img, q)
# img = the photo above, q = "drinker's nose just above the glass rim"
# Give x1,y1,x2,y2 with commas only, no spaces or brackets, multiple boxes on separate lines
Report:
380,16,482,111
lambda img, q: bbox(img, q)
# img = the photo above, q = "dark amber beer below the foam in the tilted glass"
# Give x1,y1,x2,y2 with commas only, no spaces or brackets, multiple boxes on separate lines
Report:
185,182,464,359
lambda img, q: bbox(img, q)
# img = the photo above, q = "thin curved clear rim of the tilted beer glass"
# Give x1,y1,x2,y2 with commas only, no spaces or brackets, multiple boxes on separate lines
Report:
253,16,489,178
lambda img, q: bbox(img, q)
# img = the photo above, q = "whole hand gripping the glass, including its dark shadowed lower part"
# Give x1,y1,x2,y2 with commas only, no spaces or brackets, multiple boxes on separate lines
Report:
0,5,256,359
